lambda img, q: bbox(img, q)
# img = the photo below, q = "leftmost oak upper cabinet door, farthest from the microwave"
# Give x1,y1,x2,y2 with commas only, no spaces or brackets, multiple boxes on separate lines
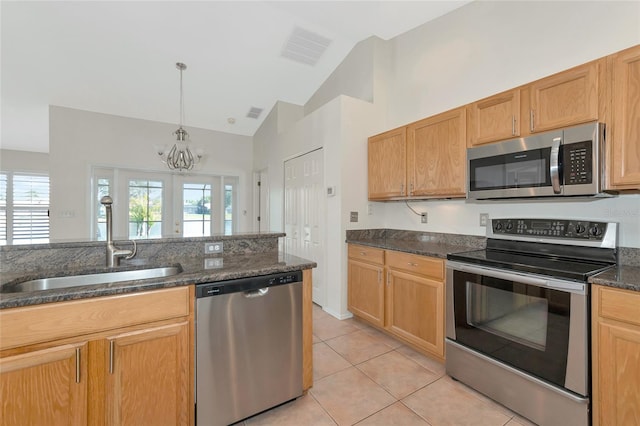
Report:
368,127,407,200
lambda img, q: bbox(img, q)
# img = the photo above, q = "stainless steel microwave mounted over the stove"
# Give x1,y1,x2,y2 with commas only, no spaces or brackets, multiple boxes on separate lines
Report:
467,122,608,200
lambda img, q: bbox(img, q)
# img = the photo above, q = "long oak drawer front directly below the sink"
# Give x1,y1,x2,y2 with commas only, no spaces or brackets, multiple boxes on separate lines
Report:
0,286,193,349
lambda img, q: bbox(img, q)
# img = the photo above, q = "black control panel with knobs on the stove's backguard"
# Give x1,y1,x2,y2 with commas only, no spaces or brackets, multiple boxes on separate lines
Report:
491,219,607,241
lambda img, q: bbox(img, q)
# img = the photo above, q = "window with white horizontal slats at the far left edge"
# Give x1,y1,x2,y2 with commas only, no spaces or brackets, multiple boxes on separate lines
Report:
0,173,49,244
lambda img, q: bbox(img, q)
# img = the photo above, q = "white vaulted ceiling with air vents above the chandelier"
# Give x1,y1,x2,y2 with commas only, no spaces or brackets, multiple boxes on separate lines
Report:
0,0,469,152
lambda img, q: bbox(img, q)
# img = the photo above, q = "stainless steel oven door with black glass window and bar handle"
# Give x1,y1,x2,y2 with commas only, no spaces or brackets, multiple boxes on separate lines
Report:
446,261,589,396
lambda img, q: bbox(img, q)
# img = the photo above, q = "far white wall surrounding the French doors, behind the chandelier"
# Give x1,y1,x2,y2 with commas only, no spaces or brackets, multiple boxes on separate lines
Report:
49,106,253,240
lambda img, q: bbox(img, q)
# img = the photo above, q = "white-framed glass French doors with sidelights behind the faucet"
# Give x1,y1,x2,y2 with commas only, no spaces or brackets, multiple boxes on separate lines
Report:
91,167,238,240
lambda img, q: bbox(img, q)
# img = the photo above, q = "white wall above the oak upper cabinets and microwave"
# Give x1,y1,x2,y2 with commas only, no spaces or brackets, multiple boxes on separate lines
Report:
387,1,640,128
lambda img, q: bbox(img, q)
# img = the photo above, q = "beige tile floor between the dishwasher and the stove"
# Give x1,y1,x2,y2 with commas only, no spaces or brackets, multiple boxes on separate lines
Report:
240,305,532,426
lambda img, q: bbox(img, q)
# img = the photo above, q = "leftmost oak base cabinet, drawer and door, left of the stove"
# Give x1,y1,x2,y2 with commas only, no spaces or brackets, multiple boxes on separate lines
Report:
347,244,385,327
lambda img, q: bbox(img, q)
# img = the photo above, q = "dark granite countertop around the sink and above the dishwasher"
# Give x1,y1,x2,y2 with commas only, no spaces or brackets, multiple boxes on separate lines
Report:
0,251,317,309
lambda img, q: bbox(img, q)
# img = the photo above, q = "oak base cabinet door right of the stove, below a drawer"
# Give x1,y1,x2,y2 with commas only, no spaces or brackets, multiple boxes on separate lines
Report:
594,323,640,425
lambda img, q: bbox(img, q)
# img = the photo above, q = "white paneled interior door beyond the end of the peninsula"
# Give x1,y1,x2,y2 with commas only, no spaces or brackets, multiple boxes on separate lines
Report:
284,149,326,306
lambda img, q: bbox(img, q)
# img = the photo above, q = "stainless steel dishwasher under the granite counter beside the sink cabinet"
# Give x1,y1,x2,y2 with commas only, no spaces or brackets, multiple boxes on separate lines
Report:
195,271,302,426
